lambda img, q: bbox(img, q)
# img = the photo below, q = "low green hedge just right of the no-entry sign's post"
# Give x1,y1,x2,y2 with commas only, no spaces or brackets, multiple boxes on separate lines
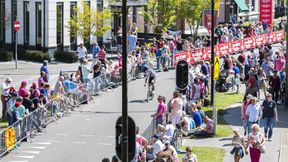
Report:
18,50,50,62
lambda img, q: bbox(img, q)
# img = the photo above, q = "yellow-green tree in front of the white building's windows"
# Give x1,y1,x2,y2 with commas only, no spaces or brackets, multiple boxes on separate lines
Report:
66,0,111,41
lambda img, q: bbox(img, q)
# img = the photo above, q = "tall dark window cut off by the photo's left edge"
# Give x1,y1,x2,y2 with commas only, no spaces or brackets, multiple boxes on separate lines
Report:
0,0,6,47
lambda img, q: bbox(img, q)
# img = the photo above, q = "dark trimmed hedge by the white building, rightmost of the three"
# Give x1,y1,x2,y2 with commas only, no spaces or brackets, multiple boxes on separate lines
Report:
54,51,78,63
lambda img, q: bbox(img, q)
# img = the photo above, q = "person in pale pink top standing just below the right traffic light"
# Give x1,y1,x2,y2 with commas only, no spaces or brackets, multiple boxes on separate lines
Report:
170,91,183,124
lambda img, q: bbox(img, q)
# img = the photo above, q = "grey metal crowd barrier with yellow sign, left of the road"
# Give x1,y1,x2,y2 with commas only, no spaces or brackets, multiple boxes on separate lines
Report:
0,73,121,159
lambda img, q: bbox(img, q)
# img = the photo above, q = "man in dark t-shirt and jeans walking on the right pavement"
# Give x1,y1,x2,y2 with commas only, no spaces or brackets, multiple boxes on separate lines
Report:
262,93,278,141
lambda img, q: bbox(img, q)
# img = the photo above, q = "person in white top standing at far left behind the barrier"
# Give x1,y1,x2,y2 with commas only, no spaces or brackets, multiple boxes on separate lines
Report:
1,78,12,119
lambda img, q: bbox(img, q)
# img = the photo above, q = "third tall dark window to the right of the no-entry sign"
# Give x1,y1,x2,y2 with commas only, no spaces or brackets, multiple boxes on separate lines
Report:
56,2,63,50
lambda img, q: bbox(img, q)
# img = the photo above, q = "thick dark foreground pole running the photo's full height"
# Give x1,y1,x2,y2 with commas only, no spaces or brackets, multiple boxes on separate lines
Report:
122,0,129,162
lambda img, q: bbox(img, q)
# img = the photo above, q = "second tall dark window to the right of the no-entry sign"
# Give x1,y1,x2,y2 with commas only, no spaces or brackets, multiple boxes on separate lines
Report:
35,2,42,49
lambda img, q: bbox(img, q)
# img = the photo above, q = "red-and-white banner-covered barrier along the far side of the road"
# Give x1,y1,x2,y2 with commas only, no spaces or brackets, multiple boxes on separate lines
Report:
173,30,285,66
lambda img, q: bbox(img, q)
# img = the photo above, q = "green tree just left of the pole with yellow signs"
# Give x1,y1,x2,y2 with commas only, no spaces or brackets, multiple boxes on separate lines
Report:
178,0,211,37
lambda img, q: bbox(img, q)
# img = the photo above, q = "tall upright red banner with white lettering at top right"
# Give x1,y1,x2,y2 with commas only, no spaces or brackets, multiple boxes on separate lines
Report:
260,0,273,26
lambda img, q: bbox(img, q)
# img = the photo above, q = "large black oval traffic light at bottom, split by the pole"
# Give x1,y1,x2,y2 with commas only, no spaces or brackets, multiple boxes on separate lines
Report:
115,116,136,161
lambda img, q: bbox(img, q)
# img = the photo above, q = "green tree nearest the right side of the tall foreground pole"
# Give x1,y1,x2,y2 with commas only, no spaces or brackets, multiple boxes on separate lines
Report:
141,0,180,33
